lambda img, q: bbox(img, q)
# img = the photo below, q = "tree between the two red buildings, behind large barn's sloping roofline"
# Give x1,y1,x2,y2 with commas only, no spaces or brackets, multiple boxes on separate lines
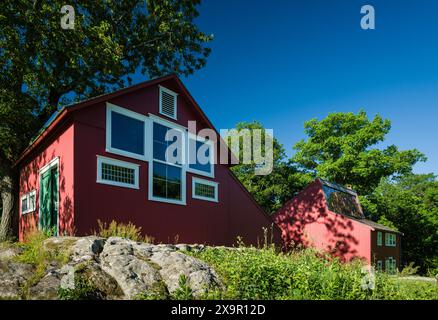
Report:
232,121,311,213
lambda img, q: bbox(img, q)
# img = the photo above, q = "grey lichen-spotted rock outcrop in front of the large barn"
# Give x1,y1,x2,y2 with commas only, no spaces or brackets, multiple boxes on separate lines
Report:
0,236,222,299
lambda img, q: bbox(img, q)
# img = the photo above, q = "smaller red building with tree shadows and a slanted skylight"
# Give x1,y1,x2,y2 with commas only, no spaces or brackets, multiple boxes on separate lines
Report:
274,179,401,271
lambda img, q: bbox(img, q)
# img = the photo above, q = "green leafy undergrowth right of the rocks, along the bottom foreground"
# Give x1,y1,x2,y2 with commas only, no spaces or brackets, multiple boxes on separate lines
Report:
188,247,438,300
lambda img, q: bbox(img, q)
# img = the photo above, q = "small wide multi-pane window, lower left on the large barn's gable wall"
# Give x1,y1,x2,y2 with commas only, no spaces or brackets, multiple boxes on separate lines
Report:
96,156,140,189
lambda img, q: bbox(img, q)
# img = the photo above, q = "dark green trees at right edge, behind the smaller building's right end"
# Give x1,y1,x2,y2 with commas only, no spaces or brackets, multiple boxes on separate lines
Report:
362,174,438,275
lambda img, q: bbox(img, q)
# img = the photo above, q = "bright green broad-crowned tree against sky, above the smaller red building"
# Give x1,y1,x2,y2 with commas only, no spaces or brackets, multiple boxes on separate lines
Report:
292,111,425,195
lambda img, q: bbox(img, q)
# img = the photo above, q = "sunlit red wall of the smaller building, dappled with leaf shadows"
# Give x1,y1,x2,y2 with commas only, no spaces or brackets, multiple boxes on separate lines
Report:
274,180,371,263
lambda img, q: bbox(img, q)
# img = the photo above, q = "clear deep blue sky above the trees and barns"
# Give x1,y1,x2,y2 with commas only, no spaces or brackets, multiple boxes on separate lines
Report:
151,0,438,174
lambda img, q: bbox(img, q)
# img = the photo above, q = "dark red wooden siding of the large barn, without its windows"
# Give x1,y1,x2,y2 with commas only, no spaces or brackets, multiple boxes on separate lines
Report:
20,79,280,245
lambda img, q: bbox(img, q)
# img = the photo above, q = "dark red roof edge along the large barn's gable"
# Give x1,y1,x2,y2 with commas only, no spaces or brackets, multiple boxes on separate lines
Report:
14,74,233,166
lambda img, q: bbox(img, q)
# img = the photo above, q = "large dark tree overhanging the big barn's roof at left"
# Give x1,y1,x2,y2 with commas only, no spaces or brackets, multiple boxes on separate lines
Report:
0,0,212,239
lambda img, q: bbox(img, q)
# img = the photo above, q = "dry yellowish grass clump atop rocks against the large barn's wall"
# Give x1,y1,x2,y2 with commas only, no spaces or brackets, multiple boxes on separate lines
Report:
94,220,154,243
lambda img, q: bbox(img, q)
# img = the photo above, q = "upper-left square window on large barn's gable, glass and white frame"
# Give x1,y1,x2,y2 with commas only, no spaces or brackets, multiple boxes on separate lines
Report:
106,102,149,161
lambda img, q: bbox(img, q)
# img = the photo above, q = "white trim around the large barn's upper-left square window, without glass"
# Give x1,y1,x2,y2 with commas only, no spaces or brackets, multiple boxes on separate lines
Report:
105,102,149,161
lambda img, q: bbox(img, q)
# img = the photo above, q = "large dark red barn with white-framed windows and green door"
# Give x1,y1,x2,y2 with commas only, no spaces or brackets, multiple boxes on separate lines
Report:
16,75,280,245
